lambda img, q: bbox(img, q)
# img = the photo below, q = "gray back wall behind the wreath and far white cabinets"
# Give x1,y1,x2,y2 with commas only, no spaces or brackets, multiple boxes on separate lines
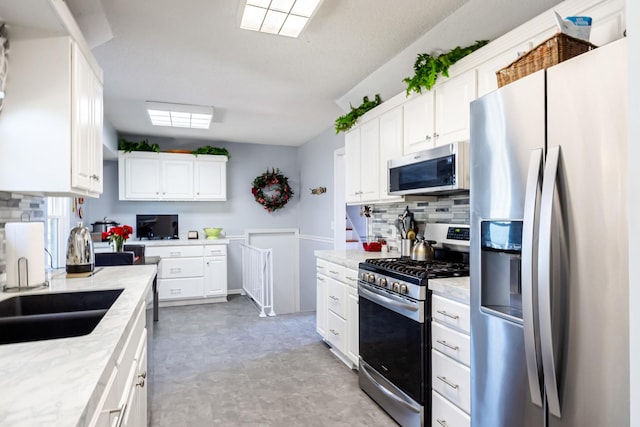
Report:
85,136,301,296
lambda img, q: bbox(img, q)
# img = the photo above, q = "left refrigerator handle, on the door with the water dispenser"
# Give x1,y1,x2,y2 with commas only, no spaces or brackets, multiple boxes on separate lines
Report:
521,148,542,407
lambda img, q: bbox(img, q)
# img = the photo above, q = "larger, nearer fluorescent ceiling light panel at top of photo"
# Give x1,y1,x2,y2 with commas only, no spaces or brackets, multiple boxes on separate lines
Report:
240,0,321,37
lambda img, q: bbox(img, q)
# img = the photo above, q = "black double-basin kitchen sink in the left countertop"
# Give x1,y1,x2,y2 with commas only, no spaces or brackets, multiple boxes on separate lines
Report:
0,289,123,344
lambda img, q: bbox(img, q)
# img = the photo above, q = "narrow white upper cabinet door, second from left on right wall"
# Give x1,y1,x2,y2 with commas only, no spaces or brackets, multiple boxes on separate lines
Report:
360,119,380,202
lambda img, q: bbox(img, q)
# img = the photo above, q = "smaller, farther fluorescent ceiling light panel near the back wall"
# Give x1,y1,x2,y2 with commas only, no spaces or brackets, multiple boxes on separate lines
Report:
146,102,213,129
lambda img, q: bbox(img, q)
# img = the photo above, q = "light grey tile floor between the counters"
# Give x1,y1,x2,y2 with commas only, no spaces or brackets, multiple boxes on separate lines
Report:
150,295,396,427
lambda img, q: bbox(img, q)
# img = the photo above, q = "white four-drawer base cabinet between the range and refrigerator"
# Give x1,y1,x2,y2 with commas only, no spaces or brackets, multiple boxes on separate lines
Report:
431,295,471,427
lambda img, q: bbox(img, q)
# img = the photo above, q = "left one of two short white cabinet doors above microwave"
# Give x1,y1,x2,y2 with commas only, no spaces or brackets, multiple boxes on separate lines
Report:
403,91,435,154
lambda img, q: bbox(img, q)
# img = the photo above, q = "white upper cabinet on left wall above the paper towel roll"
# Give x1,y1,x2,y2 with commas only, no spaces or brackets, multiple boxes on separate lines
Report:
0,36,103,197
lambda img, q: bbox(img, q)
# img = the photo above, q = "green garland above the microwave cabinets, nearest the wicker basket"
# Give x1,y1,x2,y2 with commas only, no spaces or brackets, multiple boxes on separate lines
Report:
402,40,489,95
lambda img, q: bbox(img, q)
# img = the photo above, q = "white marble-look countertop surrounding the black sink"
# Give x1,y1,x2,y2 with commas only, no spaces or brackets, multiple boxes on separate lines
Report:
0,265,156,427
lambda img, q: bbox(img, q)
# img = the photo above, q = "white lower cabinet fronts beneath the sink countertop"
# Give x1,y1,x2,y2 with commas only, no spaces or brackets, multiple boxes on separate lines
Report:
89,303,147,427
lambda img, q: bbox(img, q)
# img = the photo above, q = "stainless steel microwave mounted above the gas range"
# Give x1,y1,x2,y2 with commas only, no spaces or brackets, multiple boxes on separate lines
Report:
387,141,469,195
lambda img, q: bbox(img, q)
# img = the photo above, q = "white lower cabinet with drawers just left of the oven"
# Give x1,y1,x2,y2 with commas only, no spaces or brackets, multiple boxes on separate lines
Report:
316,259,359,368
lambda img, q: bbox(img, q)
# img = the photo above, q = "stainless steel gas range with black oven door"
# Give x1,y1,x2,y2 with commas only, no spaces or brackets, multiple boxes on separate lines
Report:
358,224,469,426
